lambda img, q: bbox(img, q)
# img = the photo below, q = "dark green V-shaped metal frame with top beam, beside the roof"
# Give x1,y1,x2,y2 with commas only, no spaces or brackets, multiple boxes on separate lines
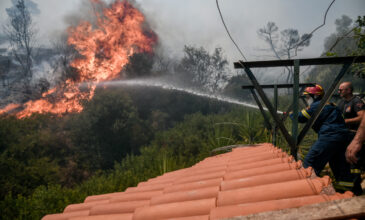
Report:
234,56,365,159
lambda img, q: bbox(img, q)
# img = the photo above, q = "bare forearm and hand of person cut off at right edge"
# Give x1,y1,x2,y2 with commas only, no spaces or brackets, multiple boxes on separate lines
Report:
346,114,365,164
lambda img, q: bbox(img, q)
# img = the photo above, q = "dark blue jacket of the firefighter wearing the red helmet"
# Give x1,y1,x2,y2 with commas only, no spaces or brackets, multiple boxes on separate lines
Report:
291,99,347,134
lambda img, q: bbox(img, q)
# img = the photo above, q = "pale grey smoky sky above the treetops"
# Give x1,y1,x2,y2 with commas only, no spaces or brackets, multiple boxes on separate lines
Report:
0,0,365,61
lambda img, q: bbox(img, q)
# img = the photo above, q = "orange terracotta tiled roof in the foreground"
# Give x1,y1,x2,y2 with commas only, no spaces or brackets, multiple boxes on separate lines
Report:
43,144,352,220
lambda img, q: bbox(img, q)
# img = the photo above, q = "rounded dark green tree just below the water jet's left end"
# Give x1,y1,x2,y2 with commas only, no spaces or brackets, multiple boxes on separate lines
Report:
71,90,150,171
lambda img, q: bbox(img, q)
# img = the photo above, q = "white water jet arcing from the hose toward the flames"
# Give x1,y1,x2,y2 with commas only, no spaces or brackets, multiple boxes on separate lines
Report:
80,79,283,114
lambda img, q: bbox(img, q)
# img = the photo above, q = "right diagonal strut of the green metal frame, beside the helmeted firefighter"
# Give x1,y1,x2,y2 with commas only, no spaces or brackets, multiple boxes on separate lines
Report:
297,63,352,145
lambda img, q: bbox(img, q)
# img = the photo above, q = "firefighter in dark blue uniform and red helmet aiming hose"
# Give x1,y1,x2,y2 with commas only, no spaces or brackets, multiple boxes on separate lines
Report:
291,85,362,195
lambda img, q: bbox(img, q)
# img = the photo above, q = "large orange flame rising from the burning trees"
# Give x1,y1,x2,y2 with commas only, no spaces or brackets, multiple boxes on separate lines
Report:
0,0,157,118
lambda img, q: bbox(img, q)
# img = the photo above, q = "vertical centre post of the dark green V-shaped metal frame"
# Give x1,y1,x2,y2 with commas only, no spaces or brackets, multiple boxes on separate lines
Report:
290,60,299,160
